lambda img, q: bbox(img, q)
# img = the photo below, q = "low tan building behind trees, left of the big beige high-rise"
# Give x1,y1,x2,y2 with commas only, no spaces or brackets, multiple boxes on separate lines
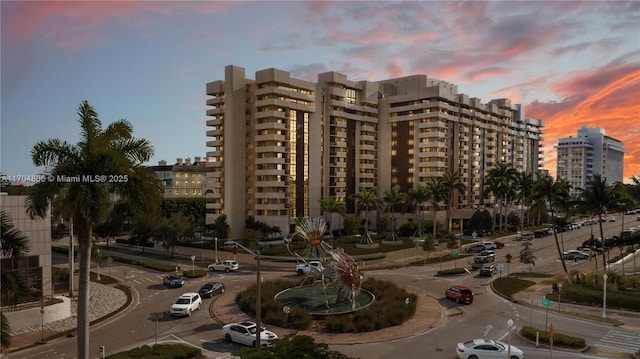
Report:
149,157,208,198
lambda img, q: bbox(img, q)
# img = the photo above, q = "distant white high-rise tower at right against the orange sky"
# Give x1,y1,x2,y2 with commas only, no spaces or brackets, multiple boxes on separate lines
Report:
555,125,624,194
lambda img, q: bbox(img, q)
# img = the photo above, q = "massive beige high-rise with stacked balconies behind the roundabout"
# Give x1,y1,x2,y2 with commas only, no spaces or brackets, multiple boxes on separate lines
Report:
207,66,543,238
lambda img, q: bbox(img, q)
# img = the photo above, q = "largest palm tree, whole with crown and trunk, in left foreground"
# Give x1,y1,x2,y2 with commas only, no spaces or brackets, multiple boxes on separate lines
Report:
27,101,162,358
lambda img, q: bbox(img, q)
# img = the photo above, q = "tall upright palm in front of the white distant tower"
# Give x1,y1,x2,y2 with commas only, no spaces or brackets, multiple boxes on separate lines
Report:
580,175,619,272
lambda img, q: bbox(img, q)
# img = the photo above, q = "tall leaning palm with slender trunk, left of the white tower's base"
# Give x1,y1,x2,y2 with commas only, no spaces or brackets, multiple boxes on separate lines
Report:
531,175,571,284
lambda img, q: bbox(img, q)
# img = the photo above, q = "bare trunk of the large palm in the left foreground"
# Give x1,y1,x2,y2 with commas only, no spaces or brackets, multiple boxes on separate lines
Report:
77,225,93,359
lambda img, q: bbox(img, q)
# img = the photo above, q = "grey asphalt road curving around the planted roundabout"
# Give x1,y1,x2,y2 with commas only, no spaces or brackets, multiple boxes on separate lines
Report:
15,216,640,359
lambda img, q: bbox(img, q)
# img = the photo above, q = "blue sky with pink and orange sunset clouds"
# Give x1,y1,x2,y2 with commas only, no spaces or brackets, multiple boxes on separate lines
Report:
0,0,640,186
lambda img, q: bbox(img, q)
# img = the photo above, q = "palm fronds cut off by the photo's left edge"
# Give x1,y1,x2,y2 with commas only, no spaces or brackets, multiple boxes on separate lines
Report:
0,210,29,351
